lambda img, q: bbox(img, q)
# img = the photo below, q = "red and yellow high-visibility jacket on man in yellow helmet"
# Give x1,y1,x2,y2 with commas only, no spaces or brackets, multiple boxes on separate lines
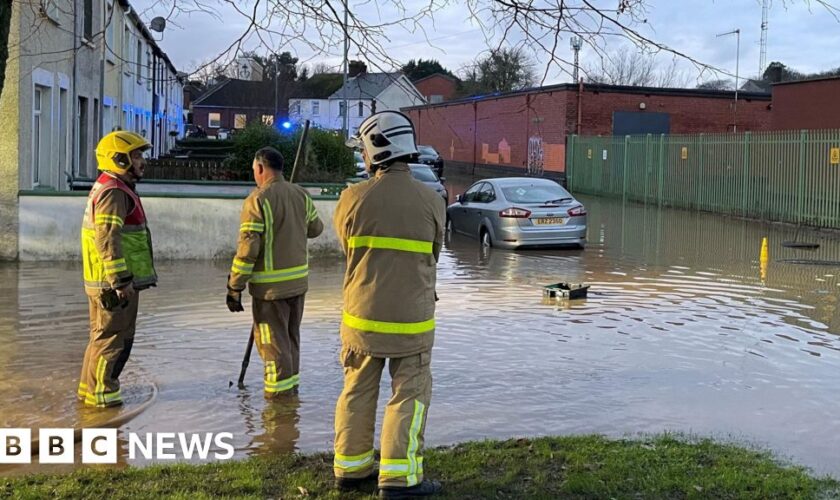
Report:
82,172,157,295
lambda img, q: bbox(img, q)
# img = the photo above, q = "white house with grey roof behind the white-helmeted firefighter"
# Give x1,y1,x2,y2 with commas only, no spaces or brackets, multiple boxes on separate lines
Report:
289,72,426,133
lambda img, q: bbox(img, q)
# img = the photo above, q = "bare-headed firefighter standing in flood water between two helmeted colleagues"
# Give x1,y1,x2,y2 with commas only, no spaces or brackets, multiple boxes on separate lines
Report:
227,147,324,399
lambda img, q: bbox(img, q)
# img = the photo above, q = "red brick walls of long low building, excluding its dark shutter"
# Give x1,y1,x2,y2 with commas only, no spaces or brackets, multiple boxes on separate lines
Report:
408,85,771,172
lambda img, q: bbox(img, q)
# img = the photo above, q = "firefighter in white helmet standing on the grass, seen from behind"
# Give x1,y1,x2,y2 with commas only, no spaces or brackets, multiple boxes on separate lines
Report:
333,111,445,498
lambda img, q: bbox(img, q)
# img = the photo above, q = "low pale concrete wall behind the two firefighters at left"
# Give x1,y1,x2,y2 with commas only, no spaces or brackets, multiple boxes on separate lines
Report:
20,194,341,261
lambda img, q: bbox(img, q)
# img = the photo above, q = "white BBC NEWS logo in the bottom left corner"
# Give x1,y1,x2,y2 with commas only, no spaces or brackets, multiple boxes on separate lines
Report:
0,428,234,464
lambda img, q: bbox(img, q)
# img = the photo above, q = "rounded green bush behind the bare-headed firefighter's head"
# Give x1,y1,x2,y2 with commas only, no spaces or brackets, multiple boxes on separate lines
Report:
225,122,355,182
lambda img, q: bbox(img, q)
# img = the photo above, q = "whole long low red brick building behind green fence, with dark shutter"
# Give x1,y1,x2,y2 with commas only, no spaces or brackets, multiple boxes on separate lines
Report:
404,84,771,177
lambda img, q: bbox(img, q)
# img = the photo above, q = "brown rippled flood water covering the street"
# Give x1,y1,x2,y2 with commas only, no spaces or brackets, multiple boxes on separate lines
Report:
0,186,840,476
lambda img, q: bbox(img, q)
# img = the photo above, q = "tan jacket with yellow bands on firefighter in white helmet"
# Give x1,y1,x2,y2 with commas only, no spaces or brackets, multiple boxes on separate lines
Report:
334,162,446,357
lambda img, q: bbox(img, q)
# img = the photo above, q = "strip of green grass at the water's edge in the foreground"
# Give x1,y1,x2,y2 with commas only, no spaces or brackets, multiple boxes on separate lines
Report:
0,435,840,499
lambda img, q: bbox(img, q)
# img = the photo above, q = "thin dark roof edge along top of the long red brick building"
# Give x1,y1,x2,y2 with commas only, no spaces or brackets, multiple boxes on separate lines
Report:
402,83,771,110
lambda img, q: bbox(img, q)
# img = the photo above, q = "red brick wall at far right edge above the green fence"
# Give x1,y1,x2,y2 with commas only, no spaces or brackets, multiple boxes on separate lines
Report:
772,79,840,130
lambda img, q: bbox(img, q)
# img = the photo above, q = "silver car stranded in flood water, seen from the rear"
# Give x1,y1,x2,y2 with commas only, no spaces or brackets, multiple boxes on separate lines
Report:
446,177,586,249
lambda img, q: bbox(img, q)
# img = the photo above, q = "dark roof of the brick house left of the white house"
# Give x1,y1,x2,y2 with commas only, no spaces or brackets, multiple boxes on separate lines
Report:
193,78,289,109
